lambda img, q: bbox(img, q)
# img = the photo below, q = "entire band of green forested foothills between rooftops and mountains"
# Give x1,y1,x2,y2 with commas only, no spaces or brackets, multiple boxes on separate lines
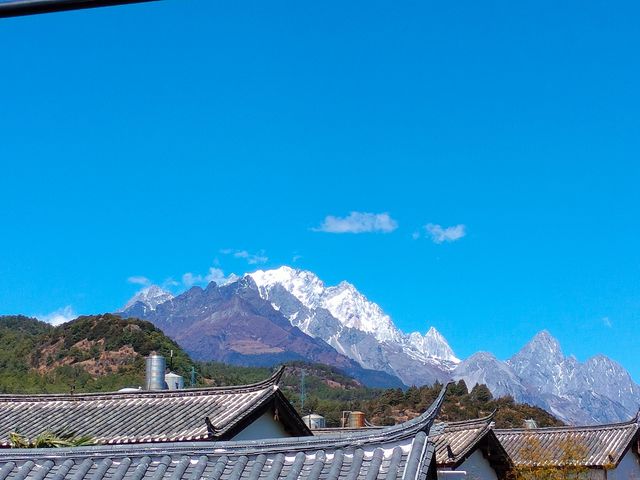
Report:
0,314,560,427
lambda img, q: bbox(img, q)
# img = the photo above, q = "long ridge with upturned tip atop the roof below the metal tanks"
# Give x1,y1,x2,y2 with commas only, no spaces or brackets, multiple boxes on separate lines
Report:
0,366,286,403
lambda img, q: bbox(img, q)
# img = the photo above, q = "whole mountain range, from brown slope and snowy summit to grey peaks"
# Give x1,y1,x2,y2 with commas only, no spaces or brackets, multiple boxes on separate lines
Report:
118,266,640,424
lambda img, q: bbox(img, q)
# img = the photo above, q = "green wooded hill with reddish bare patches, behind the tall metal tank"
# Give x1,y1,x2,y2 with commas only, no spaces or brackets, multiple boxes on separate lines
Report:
0,314,192,393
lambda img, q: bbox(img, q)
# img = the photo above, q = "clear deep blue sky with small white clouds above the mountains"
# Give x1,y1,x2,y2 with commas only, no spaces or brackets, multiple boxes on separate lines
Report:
0,0,640,380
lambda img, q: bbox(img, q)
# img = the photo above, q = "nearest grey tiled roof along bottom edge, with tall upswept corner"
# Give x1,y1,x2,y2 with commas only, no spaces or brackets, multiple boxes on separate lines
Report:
0,384,444,480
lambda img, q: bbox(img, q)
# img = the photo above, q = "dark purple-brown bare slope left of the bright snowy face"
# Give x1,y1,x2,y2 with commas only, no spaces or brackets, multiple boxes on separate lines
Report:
122,277,401,386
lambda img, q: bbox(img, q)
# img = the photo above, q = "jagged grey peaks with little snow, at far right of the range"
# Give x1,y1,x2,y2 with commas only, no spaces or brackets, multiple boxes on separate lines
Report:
453,330,640,425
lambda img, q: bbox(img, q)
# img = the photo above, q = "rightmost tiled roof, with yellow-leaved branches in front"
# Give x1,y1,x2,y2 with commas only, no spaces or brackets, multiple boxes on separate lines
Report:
495,417,639,467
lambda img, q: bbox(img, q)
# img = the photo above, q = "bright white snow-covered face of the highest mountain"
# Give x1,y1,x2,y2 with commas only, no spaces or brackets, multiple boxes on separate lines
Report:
248,267,459,385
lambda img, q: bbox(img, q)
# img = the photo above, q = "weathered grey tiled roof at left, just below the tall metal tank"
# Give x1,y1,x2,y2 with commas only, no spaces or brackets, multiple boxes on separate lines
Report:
0,369,311,447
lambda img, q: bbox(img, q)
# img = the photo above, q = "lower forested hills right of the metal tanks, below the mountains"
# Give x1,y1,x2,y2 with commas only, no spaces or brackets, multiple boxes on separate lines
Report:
199,362,562,428
